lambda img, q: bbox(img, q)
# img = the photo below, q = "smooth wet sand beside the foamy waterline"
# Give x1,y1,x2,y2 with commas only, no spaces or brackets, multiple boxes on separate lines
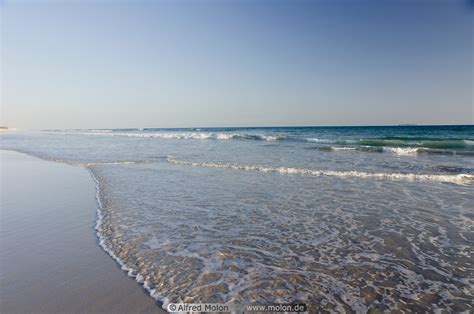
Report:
0,150,164,313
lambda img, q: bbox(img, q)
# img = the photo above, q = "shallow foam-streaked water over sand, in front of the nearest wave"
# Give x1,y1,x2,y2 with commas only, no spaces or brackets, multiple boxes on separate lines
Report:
93,164,474,310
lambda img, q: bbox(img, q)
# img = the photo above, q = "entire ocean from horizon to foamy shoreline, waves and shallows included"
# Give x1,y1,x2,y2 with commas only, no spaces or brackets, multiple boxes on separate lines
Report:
0,125,474,312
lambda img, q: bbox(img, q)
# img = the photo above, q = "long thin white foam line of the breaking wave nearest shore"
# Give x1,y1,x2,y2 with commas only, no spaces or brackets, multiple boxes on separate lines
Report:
168,158,474,185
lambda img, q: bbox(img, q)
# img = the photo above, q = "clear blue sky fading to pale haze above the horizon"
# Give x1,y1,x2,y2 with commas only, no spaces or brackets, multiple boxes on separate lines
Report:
0,0,474,129
